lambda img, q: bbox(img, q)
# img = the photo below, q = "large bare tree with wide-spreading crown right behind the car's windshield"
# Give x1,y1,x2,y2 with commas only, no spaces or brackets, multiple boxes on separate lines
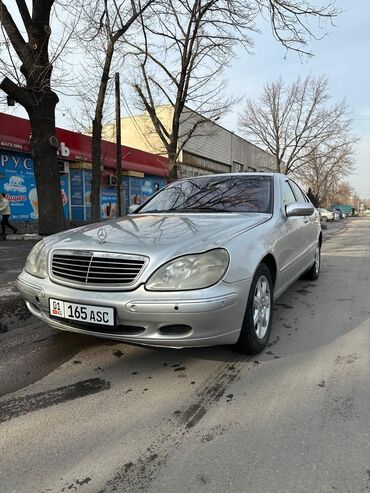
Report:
132,0,337,179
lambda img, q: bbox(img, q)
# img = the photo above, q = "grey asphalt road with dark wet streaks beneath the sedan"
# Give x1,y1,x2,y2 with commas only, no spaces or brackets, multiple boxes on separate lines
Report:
0,218,370,493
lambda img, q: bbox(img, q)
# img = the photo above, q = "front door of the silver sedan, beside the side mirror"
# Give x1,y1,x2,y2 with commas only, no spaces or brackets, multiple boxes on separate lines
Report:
276,178,310,291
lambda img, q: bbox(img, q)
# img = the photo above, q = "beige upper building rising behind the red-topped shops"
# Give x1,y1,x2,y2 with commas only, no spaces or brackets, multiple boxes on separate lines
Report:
103,105,276,176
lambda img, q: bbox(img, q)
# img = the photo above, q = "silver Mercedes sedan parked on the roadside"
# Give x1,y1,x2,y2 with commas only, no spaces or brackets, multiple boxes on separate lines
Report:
18,173,322,354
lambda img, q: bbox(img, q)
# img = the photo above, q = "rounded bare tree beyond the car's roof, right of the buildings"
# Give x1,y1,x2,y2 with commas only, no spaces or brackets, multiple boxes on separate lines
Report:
239,77,355,174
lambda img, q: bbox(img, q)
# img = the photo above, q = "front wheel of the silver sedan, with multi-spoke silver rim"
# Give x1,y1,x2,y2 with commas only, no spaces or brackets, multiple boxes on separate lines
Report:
235,264,274,354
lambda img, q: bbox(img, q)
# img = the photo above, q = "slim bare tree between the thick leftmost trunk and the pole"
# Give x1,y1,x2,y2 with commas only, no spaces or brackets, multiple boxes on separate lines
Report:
68,0,155,222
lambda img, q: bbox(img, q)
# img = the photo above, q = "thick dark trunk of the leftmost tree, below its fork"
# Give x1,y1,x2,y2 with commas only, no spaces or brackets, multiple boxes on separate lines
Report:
28,97,66,235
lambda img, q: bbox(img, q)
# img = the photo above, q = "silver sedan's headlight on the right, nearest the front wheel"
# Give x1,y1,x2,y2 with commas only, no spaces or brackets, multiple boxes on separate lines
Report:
146,249,229,291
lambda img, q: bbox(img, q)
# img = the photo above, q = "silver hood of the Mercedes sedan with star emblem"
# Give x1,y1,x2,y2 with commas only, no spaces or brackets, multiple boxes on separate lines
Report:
44,213,271,256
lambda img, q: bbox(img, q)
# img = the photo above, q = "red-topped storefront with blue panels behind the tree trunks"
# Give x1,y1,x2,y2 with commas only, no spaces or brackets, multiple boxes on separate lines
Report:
0,113,168,222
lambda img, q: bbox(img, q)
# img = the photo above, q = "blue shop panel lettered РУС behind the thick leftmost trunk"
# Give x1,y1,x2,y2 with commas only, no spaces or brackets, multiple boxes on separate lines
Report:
0,150,68,221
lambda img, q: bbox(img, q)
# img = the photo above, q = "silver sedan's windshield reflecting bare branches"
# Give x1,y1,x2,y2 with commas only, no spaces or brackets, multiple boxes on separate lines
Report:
137,175,272,214
